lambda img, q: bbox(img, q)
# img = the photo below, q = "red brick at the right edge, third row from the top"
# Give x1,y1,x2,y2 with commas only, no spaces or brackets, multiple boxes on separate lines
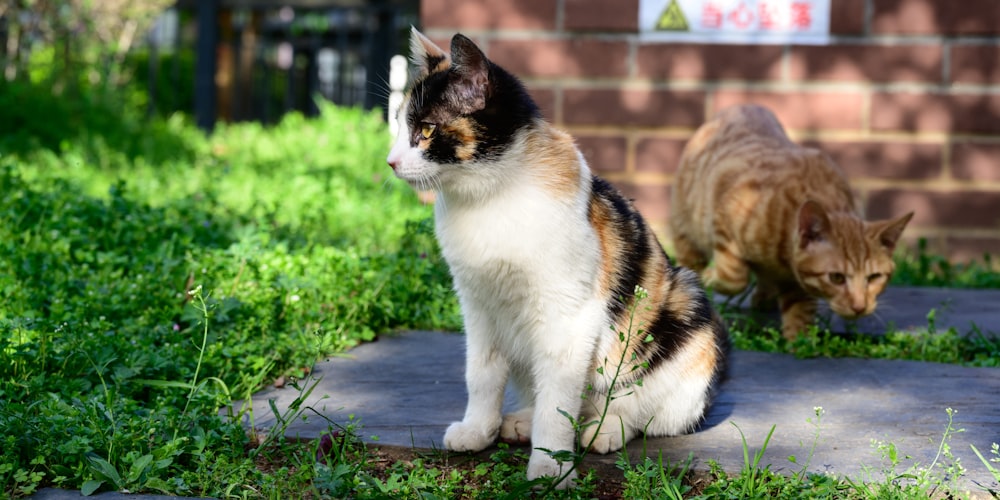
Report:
871,92,1000,133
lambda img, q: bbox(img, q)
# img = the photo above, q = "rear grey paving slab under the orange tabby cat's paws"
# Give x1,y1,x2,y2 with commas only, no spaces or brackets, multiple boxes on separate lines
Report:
716,287,1000,337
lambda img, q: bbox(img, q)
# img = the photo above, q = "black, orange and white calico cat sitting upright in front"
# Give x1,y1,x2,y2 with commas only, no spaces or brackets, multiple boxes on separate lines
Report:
387,30,728,487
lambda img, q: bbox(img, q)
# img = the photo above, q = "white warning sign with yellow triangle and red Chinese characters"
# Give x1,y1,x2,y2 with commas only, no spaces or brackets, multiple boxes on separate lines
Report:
639,0,830,45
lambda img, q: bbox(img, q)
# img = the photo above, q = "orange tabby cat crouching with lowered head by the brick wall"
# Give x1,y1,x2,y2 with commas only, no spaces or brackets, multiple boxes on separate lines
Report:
670,105,913,339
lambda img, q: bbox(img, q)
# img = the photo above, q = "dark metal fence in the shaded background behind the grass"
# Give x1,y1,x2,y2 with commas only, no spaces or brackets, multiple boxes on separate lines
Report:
167,0,418,129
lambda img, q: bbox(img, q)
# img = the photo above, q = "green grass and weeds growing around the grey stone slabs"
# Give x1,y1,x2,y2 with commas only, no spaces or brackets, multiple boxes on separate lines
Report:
0,78,1000,498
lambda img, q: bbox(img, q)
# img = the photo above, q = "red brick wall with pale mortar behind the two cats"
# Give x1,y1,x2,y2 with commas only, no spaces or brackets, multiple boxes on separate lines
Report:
421,0,1000,260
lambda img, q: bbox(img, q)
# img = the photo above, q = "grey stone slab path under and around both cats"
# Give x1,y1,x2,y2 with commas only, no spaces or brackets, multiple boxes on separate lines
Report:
240,288,1000,491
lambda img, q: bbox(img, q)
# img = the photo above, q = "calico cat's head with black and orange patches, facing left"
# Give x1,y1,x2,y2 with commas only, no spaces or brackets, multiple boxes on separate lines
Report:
386,29,539,193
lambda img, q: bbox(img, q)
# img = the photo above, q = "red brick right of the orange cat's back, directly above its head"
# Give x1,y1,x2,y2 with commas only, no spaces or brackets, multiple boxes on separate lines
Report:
802,141,944,181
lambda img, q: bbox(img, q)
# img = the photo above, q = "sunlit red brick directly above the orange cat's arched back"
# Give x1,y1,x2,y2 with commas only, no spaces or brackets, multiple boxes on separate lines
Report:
712,90,863,130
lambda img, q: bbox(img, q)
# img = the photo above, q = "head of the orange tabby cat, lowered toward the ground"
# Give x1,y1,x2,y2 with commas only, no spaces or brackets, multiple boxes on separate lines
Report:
793,201,913,319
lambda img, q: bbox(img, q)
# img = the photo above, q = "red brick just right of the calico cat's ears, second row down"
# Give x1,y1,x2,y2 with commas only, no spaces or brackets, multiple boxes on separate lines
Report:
488,38,628,78
